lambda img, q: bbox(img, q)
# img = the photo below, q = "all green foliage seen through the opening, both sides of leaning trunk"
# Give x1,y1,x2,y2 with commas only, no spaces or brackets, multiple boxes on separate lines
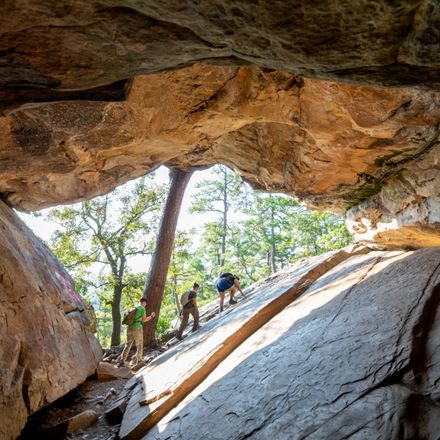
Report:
43,166,351,346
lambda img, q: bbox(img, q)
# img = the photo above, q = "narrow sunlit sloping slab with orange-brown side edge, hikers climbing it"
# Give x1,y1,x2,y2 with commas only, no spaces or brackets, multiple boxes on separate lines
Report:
119,249,365,440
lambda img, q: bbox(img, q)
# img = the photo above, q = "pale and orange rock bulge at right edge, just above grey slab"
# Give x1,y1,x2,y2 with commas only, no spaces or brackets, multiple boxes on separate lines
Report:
346,144,440,249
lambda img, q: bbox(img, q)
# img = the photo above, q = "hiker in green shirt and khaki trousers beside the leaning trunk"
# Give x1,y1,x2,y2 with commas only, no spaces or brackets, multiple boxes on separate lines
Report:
118,298,156,367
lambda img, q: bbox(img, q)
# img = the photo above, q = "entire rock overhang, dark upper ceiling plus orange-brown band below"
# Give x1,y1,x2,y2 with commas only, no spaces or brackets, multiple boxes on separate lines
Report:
0,0,440,247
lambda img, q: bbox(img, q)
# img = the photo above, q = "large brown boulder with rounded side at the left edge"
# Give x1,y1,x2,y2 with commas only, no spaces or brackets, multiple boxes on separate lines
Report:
0,202,101,440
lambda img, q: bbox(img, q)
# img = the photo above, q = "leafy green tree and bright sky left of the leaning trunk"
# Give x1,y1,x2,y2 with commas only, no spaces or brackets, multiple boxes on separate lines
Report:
49,177,165,345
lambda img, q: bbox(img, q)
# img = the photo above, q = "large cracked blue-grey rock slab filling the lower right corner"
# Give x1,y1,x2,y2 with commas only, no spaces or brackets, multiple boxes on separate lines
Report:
138,248,440,440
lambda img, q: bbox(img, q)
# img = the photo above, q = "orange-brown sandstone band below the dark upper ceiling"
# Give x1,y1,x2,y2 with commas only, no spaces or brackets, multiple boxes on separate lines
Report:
0,64,440,247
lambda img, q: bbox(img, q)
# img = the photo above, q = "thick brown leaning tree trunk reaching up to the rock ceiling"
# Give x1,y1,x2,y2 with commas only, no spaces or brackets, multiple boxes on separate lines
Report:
143,169,193,347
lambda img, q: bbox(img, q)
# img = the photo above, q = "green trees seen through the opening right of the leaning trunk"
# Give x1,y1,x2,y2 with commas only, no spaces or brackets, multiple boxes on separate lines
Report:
192,167,352,290
